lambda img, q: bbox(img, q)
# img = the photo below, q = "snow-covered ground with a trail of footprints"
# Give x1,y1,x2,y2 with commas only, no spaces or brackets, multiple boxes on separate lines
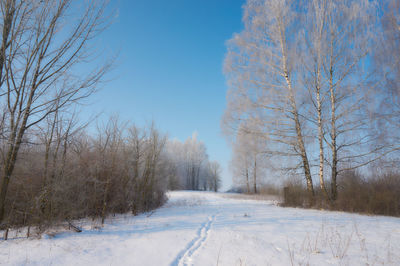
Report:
0,192,400,266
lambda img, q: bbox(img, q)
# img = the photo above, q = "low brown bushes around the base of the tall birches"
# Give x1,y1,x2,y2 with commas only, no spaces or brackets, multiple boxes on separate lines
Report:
282,171,400,216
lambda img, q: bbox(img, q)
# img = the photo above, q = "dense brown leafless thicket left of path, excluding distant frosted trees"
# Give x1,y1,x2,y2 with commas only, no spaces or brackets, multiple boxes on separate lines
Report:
0,119,168,229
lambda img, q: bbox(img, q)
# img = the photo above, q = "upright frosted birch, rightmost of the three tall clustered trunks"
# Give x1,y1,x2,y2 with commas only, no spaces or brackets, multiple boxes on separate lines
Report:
313,0,382,200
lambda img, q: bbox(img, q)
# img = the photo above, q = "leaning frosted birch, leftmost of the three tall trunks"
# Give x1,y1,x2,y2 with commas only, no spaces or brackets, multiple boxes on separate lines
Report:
224,0,314,202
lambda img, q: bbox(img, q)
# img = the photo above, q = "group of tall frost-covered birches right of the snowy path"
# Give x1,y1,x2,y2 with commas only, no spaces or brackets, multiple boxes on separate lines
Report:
223,0,400,213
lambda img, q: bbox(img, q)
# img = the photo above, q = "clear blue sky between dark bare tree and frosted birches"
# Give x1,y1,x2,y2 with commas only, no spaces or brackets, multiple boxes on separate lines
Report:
88,0,245,189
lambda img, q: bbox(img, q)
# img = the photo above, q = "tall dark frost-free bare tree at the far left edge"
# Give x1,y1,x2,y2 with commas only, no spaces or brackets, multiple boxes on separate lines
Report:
0,0,109,221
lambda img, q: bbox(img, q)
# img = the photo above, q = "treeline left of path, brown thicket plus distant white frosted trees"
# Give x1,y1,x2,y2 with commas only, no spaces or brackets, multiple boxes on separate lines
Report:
2,113,220,228
